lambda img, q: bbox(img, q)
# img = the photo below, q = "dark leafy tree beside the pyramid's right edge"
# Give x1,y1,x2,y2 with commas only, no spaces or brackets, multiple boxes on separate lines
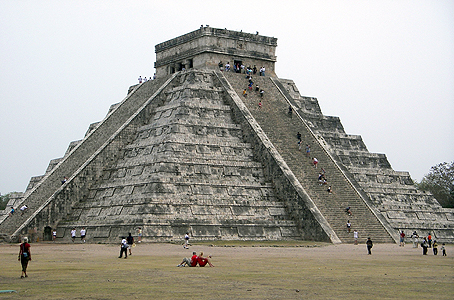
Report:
417,161,454,208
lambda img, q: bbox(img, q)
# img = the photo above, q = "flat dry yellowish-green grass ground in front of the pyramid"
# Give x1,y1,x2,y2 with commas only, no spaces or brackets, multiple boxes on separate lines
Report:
0,242,454,299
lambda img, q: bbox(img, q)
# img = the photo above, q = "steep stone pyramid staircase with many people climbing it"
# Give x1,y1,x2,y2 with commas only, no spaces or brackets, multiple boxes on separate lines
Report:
224,72,394,242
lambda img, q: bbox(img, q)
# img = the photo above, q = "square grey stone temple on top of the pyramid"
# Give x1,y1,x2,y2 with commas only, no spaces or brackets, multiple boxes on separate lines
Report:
155,26,277,77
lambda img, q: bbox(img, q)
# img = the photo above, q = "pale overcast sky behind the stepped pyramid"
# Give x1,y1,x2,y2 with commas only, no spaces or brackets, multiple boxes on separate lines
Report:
0,0,454,194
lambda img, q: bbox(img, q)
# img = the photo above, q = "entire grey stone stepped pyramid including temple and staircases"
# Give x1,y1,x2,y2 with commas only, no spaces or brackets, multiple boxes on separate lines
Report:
0,27,454,243
